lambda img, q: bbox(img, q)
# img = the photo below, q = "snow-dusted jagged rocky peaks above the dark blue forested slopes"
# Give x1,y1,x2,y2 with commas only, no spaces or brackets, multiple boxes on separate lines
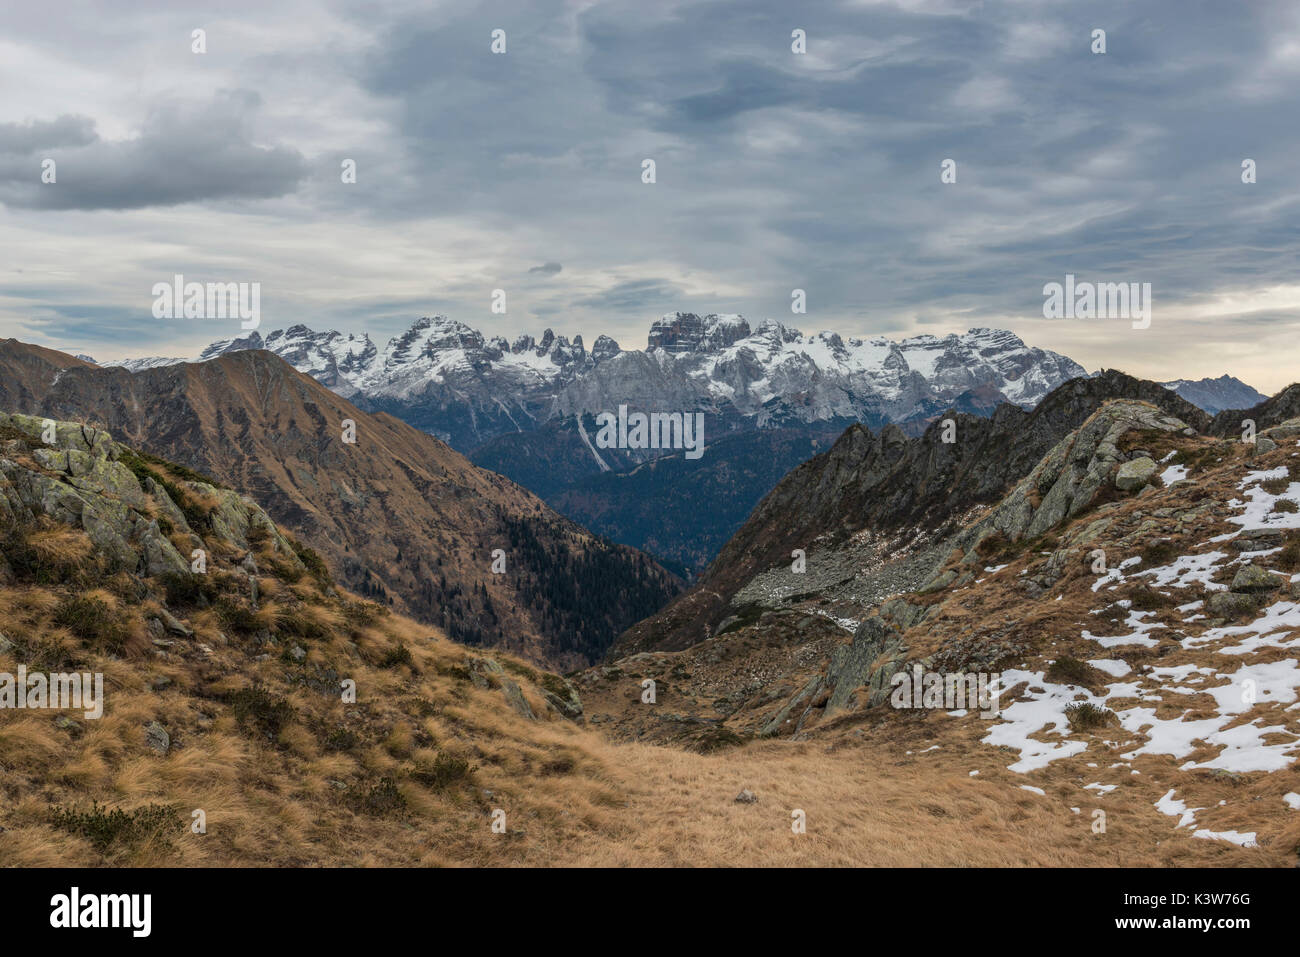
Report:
98,312,1087,450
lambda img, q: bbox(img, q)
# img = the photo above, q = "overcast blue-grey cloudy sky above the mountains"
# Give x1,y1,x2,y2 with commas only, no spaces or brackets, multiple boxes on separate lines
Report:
0,0,1300,391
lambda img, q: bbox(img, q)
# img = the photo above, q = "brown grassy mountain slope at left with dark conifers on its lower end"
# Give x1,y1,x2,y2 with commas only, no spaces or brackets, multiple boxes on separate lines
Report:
0,339,680,668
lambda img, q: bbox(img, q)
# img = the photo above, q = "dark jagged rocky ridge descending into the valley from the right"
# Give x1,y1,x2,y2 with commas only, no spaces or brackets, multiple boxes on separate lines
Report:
610,371,1210,658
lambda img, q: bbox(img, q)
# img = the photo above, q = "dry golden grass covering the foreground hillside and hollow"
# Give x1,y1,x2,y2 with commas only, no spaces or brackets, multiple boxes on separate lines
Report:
0,434,1300,867
